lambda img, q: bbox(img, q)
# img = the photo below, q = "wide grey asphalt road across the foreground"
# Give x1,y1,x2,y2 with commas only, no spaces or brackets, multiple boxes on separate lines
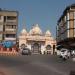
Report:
0,55,75,75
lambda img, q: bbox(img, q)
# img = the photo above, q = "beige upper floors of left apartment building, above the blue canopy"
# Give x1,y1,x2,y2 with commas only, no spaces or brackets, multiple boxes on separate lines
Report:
0,9,18,43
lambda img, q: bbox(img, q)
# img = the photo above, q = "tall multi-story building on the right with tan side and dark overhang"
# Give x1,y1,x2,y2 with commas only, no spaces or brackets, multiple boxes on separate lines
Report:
56,4,75,49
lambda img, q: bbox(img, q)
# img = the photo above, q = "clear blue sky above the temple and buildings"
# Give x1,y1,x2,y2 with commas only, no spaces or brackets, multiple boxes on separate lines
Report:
0,0,75,37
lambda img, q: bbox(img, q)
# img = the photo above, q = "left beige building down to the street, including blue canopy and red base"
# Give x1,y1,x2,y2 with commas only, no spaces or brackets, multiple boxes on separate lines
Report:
0,9,18,55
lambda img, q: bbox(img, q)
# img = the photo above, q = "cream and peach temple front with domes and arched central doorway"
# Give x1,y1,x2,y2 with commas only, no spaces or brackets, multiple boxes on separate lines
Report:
19,24,56,54
